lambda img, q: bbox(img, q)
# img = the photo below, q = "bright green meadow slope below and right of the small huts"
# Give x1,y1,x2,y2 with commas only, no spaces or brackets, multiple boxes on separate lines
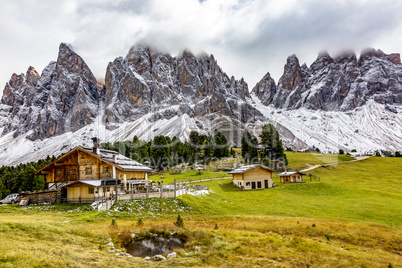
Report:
180,157,402,226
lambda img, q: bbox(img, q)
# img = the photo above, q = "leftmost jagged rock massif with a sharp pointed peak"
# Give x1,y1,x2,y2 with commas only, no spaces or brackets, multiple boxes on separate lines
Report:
0,43,103,140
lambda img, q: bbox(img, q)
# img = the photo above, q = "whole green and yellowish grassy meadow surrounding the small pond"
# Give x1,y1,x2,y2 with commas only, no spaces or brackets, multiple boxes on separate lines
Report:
0,153,402,267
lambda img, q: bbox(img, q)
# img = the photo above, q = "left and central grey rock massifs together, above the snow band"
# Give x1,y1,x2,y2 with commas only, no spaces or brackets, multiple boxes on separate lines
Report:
0,44,261,147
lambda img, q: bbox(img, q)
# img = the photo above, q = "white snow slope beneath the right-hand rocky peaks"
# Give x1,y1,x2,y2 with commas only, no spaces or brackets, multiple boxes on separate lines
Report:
252,95,402,153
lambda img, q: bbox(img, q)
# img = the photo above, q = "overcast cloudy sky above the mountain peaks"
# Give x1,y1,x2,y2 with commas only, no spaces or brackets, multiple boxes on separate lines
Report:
0,0,402,98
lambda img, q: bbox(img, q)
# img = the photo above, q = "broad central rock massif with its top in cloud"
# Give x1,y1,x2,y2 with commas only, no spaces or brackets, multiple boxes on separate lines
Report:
104,45,260,128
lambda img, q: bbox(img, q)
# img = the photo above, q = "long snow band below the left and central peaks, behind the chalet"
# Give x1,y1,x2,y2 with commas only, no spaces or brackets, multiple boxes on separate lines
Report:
0,104,217,166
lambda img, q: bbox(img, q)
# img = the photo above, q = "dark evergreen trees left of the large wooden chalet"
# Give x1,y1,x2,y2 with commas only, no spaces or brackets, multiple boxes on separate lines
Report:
0,156,56,199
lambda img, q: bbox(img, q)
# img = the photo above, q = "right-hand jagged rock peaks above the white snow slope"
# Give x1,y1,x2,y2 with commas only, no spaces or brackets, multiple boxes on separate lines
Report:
252,49,402,111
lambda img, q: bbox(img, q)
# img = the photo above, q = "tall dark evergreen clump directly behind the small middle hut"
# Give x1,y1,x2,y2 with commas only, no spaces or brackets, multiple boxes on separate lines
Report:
241,124,288,168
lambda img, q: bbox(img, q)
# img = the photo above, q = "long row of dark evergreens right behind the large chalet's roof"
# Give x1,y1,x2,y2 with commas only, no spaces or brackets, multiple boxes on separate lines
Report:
101,130,234,168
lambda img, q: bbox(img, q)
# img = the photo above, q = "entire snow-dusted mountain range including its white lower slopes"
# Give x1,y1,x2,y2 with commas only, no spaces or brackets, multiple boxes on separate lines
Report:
0,44,402,166
